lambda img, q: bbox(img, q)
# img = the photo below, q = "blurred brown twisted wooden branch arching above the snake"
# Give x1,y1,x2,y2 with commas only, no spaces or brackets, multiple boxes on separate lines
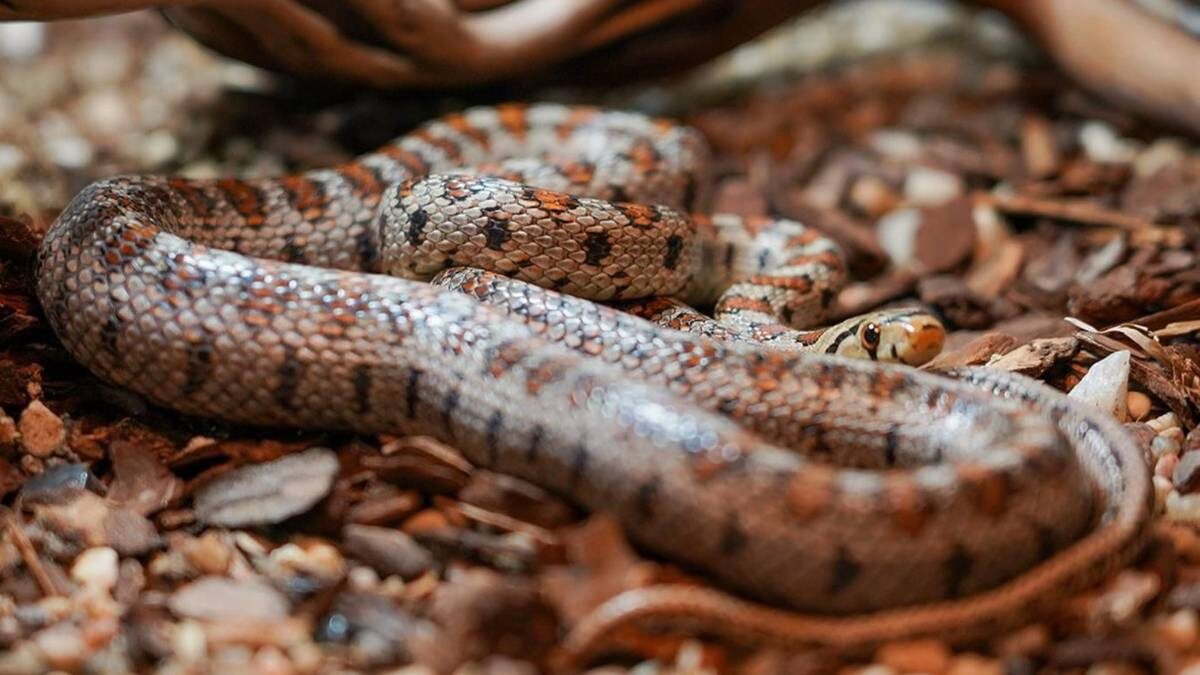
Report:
7,0,1200,133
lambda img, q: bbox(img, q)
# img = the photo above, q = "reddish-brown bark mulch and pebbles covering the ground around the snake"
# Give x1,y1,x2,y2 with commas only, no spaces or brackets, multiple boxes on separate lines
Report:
0,6,1200,675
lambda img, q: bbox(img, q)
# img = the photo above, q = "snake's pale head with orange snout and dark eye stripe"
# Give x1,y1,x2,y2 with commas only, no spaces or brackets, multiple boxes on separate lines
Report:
815,309,946,366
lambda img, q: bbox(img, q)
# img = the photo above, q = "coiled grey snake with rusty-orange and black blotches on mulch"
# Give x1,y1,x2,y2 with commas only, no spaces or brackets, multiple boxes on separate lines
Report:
35,103,1153,653
